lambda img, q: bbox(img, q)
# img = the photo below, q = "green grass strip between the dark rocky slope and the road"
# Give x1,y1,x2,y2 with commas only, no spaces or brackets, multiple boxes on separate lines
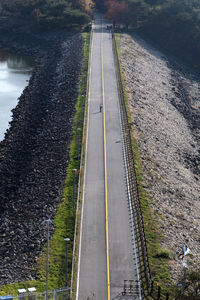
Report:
0,33,90,296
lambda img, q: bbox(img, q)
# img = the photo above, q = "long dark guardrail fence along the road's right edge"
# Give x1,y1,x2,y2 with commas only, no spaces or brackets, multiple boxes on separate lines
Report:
112,33,172,300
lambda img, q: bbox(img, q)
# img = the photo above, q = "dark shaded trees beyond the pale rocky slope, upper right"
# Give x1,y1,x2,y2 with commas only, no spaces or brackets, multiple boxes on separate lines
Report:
93,0,200,70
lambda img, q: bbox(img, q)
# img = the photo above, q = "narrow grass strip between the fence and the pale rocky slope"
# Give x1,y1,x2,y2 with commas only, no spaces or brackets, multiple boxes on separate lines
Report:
115,34,171,291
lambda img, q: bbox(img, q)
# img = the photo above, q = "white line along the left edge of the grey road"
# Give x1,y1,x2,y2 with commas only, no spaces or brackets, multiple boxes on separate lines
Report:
76,30,93,300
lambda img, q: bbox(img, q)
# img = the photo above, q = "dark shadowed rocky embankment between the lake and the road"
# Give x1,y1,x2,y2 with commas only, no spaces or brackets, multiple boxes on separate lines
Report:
0,20,83,285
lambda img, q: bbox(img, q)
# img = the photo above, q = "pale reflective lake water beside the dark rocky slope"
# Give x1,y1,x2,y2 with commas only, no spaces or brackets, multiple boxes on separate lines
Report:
0,50,33,141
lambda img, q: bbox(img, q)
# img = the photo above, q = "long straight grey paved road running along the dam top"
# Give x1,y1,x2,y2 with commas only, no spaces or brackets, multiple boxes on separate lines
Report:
76,18,139,300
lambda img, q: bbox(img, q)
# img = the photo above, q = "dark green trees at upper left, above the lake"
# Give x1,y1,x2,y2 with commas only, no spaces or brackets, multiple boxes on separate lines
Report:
0,0,89,30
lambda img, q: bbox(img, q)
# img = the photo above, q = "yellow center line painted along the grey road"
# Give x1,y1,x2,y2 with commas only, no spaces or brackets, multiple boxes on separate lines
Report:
101,21,110,300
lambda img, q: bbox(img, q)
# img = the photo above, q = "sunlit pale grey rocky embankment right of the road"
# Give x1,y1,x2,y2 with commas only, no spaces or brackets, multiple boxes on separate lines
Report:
121,35,200,281
